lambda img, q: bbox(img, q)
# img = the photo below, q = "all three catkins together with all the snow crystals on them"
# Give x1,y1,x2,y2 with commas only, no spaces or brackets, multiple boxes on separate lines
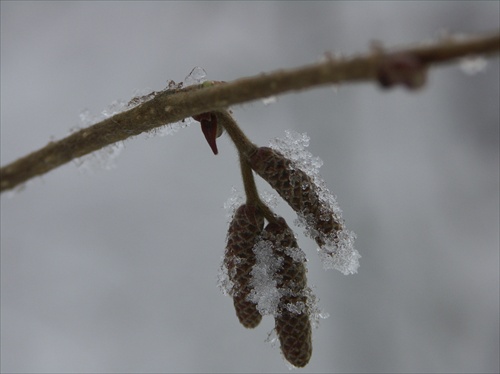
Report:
219,131,360,367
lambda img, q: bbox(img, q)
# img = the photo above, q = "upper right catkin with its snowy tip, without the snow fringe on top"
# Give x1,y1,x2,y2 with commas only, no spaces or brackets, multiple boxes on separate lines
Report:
249,147,360,274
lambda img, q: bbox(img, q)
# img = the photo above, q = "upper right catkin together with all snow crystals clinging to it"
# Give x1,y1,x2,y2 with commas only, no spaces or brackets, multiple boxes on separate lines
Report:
266,131,361,274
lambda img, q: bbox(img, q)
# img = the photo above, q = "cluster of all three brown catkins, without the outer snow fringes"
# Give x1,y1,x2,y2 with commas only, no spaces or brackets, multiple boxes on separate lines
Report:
223,147,359,367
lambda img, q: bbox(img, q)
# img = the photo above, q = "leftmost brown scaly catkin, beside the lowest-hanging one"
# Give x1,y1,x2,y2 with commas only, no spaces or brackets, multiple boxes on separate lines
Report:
224,204,264,328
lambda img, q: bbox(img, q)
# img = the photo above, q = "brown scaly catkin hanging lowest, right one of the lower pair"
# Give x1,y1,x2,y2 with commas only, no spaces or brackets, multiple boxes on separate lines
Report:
262,217,312,367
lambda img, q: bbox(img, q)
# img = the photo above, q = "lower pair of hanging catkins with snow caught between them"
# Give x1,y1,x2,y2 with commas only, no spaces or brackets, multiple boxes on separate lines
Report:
219,207,320,367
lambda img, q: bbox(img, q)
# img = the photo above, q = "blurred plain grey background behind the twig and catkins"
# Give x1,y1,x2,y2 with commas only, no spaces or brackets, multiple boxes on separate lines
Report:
1,1,500,373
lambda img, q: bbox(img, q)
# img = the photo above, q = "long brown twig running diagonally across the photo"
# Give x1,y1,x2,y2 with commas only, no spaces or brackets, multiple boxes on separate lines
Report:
0,33,500,192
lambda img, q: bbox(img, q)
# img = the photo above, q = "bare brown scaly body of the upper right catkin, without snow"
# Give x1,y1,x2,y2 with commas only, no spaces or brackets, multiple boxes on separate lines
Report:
249,147,343,247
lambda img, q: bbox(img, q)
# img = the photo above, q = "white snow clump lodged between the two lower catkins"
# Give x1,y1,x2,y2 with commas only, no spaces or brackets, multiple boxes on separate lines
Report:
248,240,283,315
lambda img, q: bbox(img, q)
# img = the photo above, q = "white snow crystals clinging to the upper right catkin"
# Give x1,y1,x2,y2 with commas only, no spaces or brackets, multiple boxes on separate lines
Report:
269,130,361,274
